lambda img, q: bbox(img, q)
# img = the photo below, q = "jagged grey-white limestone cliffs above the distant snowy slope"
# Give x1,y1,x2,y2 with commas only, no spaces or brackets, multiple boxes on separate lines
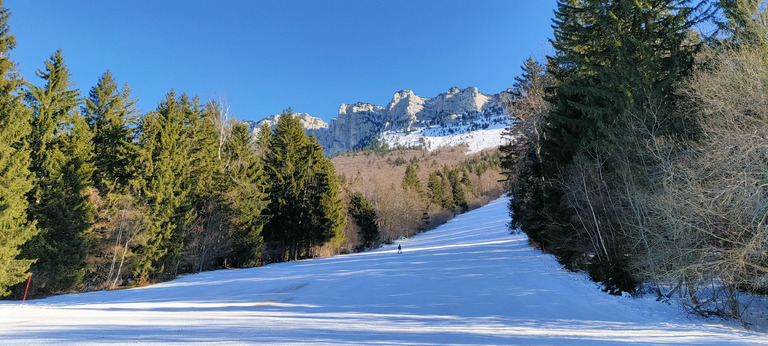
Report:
243,87,510,155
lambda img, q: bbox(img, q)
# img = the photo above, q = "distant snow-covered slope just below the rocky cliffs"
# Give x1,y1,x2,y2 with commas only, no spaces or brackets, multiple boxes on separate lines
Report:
379,122,508,154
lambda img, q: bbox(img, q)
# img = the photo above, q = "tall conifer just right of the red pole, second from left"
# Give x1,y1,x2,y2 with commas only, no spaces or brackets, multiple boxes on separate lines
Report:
23,50,94,293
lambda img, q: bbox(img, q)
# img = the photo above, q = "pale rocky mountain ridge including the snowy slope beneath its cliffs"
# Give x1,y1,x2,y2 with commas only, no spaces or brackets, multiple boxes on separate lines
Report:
243,87,511,155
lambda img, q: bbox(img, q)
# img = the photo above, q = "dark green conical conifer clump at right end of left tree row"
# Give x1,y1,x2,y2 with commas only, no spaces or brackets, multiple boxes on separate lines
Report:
264,110,346,260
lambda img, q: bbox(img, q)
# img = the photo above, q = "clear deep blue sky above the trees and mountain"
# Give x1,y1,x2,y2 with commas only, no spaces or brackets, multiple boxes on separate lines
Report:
3,0,555,121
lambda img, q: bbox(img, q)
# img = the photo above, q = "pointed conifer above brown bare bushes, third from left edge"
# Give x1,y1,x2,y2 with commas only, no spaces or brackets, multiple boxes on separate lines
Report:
83,71,137,195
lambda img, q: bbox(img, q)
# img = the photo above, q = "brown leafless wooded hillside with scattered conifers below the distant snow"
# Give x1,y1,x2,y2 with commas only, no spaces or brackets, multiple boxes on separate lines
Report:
332,146,505,251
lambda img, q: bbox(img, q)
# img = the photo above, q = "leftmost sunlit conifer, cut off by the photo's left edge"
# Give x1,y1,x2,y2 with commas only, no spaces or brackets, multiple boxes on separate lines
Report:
0,1,37,297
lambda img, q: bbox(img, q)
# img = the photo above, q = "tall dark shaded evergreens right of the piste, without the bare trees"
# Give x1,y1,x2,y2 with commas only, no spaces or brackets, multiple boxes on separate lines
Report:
510,0,699,293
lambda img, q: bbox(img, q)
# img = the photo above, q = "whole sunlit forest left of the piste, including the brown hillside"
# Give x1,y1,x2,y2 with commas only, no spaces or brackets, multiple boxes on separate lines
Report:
0,2,503,299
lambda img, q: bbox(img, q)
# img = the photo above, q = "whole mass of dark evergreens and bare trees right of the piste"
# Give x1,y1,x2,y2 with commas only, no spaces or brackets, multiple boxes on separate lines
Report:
503,0,768,319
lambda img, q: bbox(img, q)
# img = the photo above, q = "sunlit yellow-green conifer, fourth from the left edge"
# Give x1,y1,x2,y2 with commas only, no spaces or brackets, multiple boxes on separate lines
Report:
135,91,194,284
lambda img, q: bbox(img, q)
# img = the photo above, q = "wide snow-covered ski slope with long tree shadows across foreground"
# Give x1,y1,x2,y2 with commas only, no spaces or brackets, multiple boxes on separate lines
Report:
0,198,768,345
